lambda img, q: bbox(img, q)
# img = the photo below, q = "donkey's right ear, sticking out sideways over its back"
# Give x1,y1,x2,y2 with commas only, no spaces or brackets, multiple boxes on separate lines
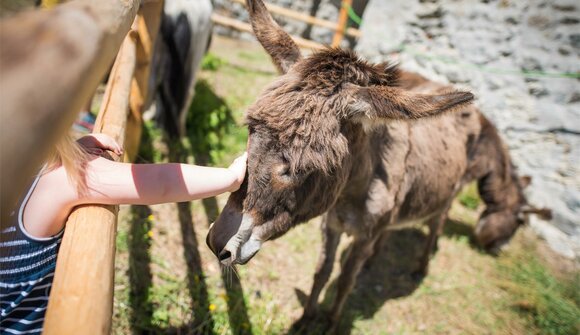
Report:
344,84,473,120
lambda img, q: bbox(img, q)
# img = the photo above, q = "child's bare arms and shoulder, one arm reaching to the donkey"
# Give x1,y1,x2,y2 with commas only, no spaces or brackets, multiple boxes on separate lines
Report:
23,135,247,237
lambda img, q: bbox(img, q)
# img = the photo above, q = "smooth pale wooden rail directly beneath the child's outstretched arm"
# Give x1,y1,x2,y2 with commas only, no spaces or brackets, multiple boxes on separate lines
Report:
44,31,137,335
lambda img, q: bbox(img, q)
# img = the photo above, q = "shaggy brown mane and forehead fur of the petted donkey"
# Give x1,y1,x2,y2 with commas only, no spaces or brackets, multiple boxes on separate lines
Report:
247,48,399,173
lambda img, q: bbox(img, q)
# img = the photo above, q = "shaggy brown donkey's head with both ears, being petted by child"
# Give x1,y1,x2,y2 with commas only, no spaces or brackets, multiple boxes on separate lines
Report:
207,0,473,264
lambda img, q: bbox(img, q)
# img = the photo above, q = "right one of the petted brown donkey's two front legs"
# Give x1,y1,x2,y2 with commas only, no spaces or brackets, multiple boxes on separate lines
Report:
330,237,378,327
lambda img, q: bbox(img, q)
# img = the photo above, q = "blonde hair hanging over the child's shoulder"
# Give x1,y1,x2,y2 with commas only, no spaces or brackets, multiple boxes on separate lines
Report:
45,134,89,194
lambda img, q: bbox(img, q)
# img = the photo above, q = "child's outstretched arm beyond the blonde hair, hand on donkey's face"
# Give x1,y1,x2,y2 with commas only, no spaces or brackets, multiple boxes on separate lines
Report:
76,154,246,205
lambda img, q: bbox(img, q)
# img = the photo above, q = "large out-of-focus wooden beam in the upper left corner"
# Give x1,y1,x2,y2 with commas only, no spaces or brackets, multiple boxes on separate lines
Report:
0,0,141,224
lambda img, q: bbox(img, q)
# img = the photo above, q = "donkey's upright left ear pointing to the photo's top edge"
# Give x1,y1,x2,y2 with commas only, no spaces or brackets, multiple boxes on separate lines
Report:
246,0,301,74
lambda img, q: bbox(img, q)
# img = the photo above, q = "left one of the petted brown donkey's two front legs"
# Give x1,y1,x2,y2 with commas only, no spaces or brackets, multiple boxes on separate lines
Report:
302,210,341,319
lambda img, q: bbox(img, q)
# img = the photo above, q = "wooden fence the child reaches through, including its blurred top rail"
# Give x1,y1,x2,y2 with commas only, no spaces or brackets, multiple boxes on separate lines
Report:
0,0,163,335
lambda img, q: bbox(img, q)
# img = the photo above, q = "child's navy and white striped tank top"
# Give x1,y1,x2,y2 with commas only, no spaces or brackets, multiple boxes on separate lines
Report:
0,177,62,335
